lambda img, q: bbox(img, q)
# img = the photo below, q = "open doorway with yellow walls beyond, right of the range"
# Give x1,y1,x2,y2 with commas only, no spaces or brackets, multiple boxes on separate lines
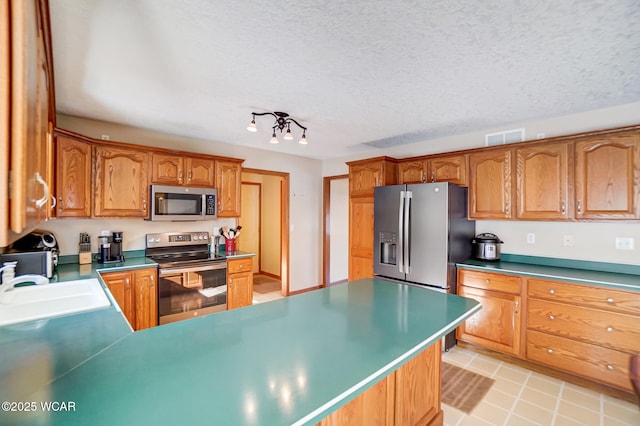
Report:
238,168,289,296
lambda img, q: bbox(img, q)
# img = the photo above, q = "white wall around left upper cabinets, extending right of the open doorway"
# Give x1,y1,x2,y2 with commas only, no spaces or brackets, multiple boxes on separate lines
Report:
48,115,322,291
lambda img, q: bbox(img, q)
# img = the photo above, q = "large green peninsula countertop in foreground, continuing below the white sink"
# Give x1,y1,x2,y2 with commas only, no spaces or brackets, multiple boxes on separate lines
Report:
0,279,480,425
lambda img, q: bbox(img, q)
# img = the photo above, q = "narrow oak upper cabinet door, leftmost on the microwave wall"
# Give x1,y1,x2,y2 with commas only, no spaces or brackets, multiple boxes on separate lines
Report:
56,136,91,217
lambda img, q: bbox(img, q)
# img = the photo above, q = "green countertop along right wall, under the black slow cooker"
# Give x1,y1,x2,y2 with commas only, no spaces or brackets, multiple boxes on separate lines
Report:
457,255,640,291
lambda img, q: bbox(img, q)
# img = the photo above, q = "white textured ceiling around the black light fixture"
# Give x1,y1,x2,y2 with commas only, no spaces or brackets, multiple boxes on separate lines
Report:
50,0,640,159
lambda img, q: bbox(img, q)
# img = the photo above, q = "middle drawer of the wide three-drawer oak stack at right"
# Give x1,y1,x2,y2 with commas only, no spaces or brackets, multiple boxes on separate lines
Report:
528,299,640,353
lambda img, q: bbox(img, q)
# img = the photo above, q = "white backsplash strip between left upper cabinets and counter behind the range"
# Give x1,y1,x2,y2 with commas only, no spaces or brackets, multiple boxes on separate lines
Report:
38,218,236,255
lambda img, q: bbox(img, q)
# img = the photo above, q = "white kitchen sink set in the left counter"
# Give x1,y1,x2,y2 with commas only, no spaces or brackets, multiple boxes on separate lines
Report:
0,278,111,326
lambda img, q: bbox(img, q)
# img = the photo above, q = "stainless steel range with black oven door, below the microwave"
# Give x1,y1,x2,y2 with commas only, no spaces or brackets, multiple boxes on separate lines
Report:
145,232,227,324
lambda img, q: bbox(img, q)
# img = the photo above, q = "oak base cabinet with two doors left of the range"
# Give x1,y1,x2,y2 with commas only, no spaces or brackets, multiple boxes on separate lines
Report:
100,268,158,331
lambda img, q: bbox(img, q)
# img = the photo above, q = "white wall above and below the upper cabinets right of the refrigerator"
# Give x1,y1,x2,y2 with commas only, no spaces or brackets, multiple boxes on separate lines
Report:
322,102,640,265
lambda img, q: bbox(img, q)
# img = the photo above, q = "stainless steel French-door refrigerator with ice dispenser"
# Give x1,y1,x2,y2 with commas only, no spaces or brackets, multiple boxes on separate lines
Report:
373,182,475,350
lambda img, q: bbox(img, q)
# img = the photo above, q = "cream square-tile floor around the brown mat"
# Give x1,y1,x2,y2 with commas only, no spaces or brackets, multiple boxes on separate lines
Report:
442,346,640,426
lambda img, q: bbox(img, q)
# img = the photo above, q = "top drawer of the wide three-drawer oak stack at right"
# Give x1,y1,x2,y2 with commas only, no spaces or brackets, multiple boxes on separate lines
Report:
527,278,640,315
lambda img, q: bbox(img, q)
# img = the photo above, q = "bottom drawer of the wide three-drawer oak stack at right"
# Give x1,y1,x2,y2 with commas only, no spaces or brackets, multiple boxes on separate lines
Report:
527,330,633,392
